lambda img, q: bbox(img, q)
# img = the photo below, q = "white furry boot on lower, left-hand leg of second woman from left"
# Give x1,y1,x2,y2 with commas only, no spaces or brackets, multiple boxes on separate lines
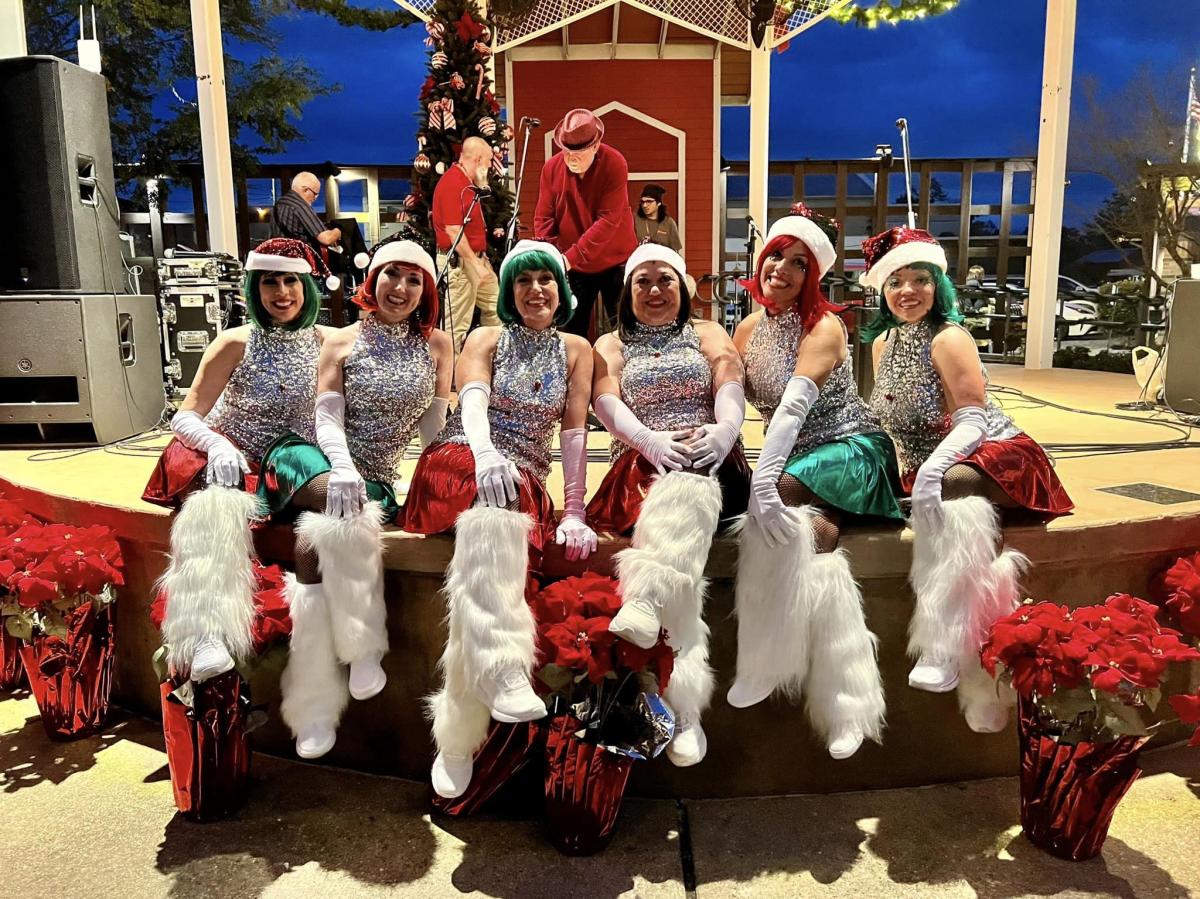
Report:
280,574,349,759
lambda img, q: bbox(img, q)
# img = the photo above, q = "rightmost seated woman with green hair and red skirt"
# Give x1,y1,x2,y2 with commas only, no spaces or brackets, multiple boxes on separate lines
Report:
863,227,1074,733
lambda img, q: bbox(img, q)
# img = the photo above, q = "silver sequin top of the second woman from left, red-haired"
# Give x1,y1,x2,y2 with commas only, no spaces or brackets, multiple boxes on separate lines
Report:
342,316,437,484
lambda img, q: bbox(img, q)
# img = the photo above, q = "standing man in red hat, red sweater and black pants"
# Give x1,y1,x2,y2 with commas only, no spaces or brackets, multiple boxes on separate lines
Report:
533,109,637,337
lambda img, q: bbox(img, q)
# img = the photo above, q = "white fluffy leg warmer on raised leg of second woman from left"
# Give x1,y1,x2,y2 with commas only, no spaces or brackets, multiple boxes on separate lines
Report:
295,503,388,665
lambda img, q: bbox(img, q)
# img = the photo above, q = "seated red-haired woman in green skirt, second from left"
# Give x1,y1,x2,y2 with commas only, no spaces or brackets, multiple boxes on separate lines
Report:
248,240,452,759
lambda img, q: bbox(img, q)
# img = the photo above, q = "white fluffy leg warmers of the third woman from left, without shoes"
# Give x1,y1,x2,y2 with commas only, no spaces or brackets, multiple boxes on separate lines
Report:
426,507,536,757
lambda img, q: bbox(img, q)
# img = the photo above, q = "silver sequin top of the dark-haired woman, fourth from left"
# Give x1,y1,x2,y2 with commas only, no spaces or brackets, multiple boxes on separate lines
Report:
610,322,715,462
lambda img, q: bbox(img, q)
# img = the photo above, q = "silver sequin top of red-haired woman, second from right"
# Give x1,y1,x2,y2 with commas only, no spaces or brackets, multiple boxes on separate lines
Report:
745,308,883,455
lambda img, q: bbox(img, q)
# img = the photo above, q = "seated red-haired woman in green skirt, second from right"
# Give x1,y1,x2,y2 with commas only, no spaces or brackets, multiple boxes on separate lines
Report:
727,204,904,759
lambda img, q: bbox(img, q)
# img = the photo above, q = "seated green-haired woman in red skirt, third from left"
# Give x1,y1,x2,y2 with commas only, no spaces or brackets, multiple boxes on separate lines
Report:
403,240,596,798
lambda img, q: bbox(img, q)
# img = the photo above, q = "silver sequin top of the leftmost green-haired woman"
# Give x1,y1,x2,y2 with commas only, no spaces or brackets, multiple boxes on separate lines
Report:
208,328,320,461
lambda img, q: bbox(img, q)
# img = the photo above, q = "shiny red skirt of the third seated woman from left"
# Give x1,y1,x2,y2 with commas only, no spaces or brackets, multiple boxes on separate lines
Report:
396,443,558,558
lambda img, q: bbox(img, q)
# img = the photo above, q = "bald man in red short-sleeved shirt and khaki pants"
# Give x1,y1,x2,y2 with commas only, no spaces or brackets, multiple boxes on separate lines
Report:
433,137,500,355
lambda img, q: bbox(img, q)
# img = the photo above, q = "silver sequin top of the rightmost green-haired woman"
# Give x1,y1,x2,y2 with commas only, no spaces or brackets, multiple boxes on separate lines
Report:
871,319,1021,472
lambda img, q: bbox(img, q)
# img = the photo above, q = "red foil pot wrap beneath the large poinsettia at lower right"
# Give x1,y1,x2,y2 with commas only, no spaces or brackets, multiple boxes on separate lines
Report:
1018,700,1150,862
